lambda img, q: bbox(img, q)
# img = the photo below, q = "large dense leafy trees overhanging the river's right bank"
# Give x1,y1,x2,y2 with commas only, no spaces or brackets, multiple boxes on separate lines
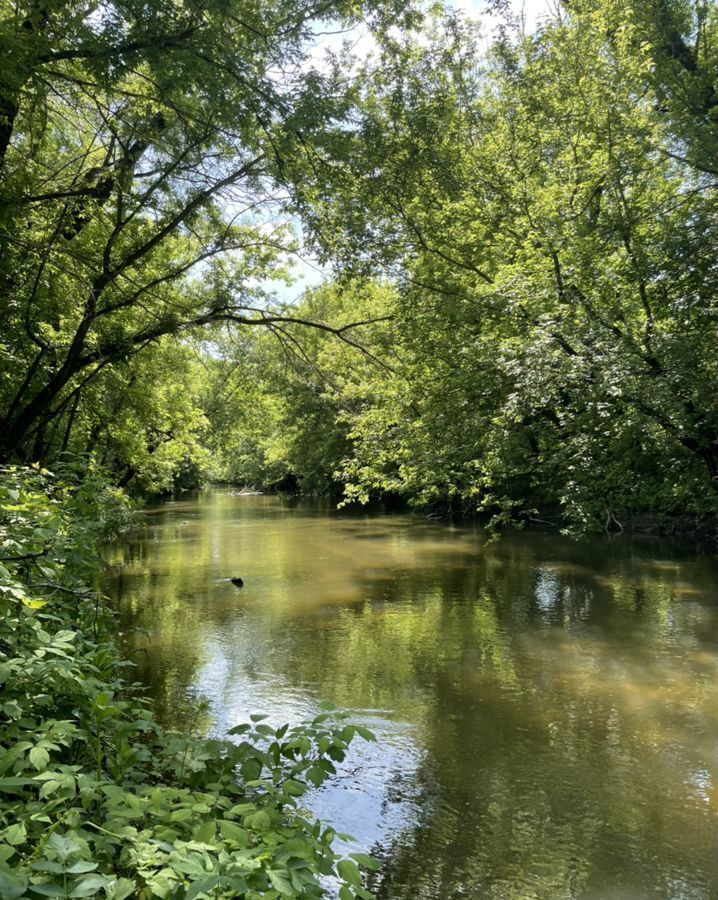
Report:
290,0,718,527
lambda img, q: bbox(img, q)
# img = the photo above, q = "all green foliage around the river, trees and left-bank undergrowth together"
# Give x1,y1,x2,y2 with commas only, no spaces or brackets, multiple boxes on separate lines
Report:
0,0,718,900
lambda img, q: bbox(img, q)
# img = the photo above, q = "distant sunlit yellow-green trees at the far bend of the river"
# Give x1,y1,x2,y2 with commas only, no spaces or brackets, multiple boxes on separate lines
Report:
204,282,395,494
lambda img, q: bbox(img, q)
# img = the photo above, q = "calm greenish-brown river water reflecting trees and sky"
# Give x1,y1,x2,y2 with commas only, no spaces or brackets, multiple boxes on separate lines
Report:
106,490,718,900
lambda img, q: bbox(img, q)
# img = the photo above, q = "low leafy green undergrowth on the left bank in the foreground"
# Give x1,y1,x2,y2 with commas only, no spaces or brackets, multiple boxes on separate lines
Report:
0,468,380,900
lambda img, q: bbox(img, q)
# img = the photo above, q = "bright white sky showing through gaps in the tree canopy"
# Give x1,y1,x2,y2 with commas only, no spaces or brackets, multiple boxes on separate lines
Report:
264,0,556,303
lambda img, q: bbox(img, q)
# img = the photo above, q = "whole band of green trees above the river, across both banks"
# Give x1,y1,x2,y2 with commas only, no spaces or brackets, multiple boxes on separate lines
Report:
0,0,718,528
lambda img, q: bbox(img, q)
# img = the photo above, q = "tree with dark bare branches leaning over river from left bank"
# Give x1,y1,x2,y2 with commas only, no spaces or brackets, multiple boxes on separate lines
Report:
0,0,414,459
